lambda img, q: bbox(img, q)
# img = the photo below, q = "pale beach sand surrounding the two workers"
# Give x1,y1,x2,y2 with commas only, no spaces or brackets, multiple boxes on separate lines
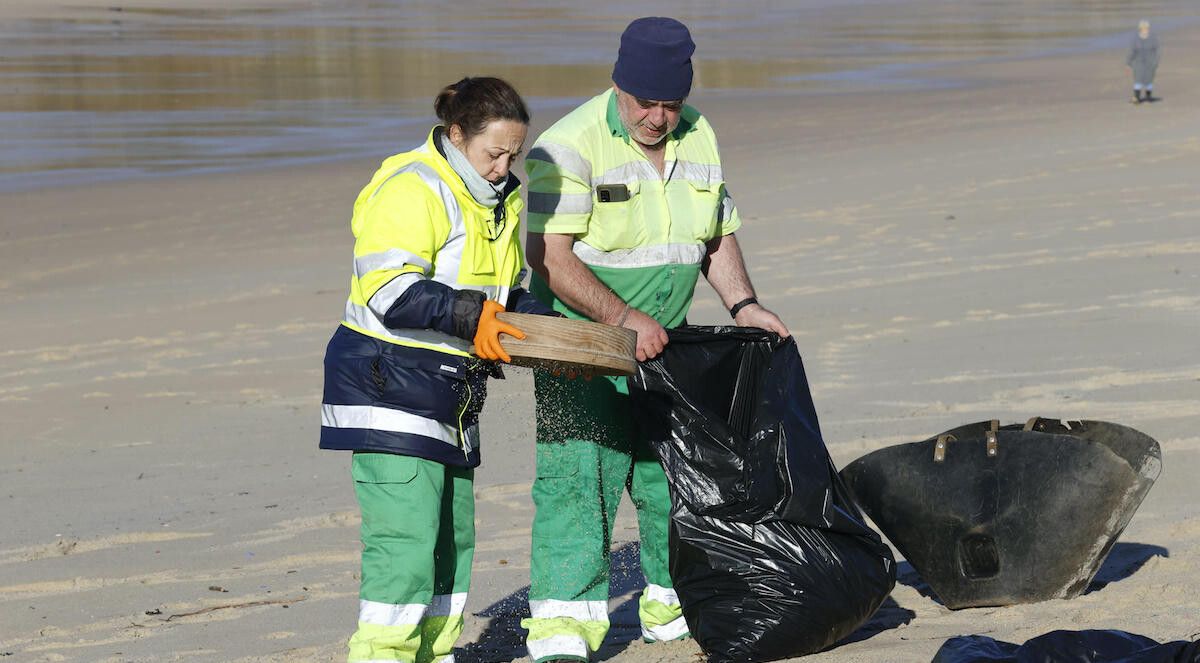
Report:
0,12,1200,663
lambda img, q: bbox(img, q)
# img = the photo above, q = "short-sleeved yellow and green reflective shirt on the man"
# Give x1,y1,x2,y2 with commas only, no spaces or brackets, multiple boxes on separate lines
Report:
526,89,742,328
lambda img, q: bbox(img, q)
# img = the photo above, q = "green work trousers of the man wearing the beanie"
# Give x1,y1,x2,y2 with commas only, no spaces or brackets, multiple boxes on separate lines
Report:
521,371,688,662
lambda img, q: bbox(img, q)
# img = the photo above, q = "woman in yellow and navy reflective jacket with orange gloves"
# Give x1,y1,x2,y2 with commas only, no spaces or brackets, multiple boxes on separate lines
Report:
320,78,554,663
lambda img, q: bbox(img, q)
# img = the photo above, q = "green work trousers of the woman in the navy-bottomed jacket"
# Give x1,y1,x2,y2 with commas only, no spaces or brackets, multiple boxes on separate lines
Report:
349,453,475,663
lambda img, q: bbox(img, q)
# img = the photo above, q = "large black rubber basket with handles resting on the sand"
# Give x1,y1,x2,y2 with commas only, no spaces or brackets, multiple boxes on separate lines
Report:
841,417,1162,609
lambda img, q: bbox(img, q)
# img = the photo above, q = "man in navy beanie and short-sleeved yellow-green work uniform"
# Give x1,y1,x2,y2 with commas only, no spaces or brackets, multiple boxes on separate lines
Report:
522,17,788,663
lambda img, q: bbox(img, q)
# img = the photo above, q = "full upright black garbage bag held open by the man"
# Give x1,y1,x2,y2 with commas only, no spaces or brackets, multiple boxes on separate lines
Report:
630,327,895,663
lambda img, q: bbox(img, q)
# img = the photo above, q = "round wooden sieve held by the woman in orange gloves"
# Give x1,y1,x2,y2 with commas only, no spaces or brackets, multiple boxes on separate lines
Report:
496,312,637,375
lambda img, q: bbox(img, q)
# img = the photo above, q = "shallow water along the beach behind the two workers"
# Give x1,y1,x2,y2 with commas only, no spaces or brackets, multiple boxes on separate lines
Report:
0,0,1189,191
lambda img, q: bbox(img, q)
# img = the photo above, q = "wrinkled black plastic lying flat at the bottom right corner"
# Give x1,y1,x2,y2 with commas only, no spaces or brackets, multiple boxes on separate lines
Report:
931,631,1200,663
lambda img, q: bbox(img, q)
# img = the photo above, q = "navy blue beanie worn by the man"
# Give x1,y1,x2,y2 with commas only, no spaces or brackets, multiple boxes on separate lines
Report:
612,16,696,101
